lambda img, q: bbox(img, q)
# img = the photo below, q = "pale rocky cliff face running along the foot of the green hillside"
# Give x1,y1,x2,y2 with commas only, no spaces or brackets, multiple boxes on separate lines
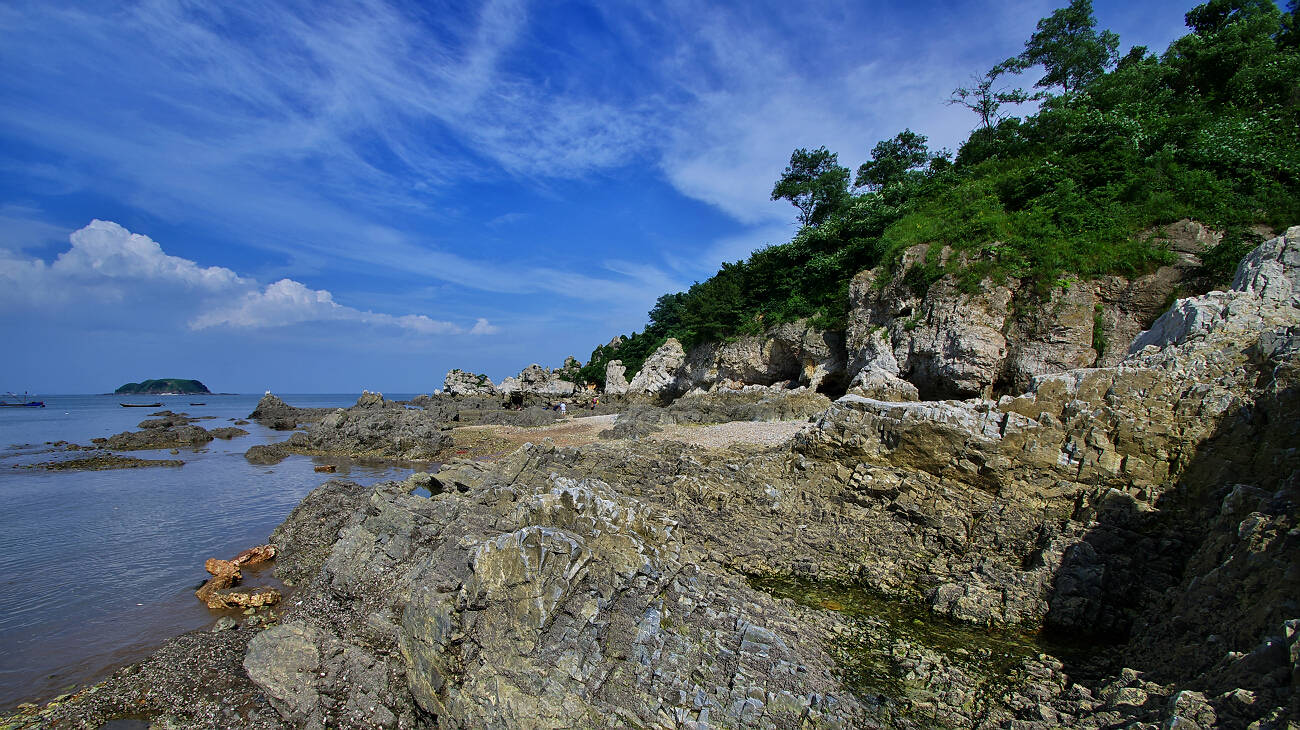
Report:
616,221,1216,400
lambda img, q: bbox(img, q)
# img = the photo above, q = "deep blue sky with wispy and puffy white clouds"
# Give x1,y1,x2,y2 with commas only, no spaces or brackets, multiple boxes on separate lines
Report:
0,0,1191,394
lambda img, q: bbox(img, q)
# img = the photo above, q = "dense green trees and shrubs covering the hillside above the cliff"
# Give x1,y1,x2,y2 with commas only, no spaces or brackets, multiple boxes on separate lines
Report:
581,0,1300,381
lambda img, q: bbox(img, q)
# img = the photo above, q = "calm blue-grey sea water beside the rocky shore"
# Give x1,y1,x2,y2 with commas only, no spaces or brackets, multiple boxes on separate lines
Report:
0,394,423,711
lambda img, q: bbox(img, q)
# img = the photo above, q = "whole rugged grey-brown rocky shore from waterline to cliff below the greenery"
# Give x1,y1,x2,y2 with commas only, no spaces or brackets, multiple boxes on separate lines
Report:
5,226,1300,730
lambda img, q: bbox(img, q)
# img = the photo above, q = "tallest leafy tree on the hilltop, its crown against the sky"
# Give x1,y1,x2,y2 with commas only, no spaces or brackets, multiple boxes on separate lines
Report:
1005,0,1119,94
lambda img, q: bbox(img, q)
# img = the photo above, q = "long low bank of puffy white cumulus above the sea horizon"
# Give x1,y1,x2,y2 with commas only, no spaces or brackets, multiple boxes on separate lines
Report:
0,220,498,335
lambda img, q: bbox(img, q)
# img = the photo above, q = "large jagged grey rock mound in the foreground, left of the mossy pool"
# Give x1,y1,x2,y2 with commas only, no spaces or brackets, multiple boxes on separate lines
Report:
244,467,865,727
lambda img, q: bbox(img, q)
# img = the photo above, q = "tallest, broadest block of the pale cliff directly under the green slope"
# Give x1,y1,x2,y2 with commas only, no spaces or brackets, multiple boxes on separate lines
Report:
846,227,1214,399
